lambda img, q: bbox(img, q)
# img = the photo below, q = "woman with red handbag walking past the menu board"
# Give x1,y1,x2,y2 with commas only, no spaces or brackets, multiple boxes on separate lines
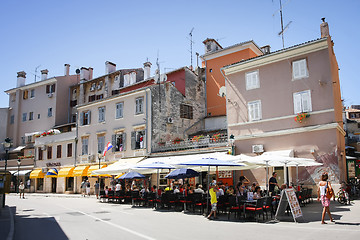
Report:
317,173,335,224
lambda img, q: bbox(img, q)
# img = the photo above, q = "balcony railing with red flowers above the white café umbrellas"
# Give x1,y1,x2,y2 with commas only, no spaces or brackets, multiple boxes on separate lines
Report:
152,135,229,152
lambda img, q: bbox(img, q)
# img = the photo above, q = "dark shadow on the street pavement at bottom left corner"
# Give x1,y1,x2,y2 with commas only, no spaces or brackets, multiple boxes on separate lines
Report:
14,211,69,240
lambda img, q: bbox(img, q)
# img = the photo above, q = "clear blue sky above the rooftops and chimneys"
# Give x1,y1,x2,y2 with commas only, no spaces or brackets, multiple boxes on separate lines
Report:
0,0,360,108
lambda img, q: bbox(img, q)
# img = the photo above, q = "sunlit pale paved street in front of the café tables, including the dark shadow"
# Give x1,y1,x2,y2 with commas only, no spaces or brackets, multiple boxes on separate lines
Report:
4,194,360,240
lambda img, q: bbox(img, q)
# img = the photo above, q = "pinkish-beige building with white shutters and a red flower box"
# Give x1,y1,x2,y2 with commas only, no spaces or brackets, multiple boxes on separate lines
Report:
222,22,346,185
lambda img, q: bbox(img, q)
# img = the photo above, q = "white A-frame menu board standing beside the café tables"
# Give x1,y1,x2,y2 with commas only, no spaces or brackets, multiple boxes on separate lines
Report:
275,188,303,222
